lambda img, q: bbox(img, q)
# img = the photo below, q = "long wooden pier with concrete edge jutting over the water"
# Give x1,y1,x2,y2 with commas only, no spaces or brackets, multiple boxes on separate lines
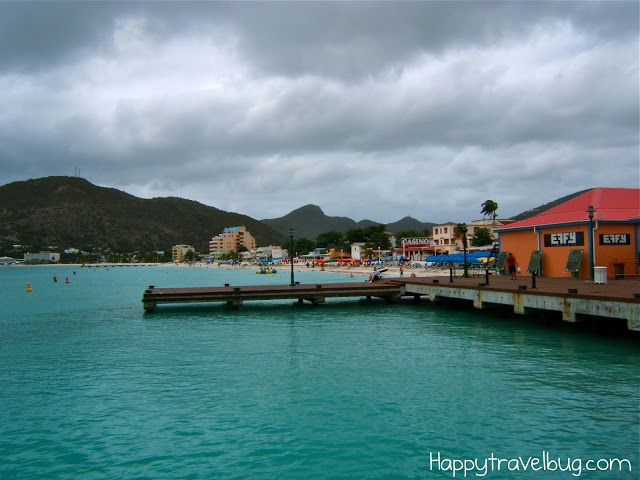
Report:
142,275,640,331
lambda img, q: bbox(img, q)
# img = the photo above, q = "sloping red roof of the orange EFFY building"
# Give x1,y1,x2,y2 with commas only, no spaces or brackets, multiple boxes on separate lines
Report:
496,187,640,230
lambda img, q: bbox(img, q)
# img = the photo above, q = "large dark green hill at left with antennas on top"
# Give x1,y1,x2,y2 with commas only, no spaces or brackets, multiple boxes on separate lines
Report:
0,177,285,252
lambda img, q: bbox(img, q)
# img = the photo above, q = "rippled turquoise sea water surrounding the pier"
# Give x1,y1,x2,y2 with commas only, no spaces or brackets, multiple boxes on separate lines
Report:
0,267,640,479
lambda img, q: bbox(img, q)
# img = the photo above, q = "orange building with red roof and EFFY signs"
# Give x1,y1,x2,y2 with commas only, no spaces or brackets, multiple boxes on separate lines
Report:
496,187,640,279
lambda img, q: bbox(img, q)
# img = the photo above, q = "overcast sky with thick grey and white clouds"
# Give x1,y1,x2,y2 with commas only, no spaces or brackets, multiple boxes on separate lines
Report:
0,1,640,222
